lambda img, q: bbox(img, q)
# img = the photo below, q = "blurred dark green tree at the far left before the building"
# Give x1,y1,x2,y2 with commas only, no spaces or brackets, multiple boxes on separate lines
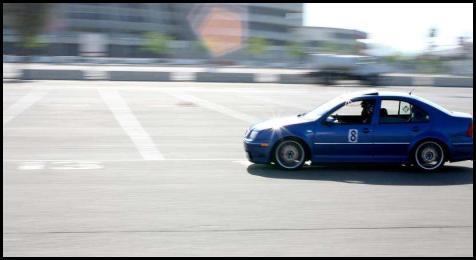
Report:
3,3,53,56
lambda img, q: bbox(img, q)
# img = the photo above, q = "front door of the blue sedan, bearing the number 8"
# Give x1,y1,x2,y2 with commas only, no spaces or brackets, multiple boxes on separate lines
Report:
313,98,376,162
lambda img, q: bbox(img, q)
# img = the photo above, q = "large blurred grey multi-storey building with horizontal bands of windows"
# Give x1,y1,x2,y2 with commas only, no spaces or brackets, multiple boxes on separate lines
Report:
3,3,303,58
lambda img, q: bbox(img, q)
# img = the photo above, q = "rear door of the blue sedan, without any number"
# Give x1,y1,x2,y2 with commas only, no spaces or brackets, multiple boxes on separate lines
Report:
373,98,430,162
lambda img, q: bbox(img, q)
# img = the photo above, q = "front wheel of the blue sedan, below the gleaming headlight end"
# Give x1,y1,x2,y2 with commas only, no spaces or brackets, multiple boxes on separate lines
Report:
274,140,306,170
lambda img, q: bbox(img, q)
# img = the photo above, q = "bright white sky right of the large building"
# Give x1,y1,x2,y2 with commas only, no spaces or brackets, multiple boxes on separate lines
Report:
304,3,473,55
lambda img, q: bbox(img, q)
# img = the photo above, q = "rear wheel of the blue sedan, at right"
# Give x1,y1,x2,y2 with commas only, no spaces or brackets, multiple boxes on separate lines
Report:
414,141,445,172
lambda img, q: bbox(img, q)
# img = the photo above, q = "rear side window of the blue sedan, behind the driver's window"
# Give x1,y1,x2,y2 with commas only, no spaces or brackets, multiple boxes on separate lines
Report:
379,100,430,124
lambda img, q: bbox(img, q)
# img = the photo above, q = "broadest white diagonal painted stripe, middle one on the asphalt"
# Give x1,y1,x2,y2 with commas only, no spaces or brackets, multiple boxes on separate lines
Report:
98,88,164,160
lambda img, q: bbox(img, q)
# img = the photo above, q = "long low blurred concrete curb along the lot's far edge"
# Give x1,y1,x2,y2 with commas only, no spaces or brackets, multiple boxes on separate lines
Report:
4,69,473,88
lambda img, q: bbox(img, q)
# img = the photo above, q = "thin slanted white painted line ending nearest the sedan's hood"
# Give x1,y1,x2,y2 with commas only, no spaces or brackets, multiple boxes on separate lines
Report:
162,90,260,123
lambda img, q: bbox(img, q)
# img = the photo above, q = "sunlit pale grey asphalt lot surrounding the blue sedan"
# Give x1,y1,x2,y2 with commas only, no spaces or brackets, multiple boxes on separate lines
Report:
3,80,473,256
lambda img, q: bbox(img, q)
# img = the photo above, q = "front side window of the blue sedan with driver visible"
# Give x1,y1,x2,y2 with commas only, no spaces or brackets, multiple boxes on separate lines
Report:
330,100,375,124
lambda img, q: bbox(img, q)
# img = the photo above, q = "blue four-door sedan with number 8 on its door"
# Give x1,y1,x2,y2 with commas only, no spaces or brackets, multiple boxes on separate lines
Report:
244,91,473,171
